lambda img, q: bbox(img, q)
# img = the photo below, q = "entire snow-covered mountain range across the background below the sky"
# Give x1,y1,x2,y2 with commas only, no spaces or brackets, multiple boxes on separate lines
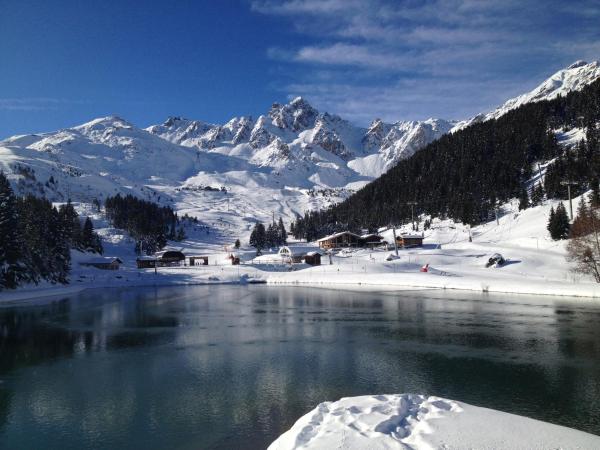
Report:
0,62,600,236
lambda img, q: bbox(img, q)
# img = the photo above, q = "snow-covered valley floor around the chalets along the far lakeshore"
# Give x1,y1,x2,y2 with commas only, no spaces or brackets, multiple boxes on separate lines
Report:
0,190,600,300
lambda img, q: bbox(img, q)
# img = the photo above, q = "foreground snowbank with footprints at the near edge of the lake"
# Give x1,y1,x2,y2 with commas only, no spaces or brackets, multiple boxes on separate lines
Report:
269,394,600,450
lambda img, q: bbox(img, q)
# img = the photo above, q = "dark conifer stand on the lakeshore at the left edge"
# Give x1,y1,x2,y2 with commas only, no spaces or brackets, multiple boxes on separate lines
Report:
0,172,102,289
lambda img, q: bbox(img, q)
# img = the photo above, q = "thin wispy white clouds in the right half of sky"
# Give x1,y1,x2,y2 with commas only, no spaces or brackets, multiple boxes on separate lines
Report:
252,0,600,122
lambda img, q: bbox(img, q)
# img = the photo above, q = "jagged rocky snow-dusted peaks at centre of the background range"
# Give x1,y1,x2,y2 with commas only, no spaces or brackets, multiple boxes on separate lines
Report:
147,97,453,177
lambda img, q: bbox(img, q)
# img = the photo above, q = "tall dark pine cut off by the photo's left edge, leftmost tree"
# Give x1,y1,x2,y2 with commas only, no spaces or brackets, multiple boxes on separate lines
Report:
0,172,23,289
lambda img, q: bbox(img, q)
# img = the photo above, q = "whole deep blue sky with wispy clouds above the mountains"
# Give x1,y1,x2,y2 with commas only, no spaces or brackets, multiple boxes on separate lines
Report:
0,0,600,137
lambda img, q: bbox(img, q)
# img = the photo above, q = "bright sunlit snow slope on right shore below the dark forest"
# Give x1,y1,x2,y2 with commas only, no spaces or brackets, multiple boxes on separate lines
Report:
268,195,600,297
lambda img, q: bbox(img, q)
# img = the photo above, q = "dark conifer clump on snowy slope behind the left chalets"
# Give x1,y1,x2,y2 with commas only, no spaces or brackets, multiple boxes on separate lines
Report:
104,194,186,255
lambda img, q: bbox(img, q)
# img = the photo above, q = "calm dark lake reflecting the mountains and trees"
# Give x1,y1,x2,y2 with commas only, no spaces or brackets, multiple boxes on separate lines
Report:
0,286,600,450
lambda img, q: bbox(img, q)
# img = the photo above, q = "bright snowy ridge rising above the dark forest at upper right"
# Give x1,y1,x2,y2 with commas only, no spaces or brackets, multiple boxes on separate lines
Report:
452,61,600,132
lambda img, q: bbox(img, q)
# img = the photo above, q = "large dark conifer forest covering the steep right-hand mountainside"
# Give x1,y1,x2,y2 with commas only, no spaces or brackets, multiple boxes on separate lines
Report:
292,80,600,240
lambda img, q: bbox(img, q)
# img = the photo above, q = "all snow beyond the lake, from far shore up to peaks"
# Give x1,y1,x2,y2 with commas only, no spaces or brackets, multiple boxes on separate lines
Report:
0,62,600,299
